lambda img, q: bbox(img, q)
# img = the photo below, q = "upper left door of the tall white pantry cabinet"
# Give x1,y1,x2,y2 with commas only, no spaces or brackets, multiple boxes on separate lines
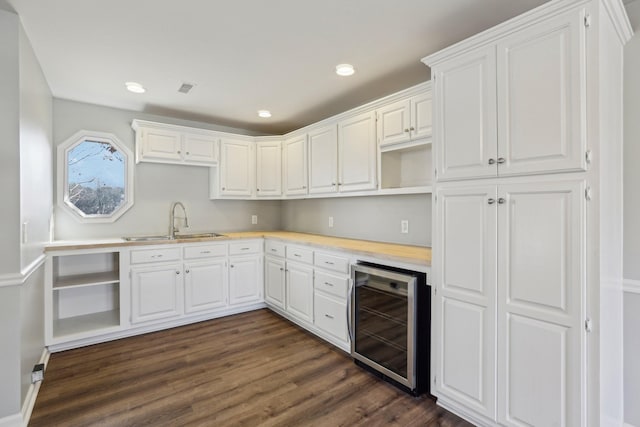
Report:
432,46,498,181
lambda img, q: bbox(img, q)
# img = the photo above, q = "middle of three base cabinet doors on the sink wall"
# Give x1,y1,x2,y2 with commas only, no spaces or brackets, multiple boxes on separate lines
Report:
184,259,227,313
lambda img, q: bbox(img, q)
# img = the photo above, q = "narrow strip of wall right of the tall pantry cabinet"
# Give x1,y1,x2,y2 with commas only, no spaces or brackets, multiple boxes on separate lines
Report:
624,0,640,426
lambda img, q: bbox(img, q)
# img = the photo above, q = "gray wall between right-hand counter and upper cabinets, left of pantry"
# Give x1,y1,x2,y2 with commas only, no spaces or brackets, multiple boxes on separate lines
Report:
282,194,431,246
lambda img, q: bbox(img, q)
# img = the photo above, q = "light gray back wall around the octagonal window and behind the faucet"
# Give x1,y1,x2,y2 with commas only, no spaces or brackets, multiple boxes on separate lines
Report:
53,99,281,240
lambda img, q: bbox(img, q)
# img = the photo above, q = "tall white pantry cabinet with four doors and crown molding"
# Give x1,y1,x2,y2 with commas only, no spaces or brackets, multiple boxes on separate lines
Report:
423,0,632,426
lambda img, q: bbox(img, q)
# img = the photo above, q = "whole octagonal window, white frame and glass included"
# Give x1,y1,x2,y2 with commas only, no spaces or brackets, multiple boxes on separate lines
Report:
58,131,133,222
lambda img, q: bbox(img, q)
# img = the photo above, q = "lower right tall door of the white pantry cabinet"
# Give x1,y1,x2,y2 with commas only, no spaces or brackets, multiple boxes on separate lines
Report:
497,181,586,426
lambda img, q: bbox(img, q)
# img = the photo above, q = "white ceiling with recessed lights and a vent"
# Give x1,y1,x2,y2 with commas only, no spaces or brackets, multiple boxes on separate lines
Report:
4,0,580,134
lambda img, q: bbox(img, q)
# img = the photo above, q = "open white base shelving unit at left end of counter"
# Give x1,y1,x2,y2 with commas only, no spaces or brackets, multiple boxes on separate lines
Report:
47,251,121,343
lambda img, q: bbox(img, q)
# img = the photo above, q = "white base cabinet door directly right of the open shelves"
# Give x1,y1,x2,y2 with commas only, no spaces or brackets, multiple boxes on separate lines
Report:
131,264,183,323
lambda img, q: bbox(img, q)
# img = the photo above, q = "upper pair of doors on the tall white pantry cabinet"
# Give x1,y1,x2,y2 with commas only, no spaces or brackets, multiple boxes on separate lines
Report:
433,6,586,181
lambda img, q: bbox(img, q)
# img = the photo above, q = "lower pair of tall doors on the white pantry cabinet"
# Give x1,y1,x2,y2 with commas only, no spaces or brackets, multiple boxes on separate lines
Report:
432,179,586,426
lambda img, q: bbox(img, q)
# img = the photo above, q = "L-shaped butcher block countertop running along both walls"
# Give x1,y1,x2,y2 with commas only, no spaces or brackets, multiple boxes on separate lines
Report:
45,231,431,266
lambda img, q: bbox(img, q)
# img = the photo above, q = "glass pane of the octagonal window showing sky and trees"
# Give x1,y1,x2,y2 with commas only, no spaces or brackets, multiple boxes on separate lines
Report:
67,139,126,216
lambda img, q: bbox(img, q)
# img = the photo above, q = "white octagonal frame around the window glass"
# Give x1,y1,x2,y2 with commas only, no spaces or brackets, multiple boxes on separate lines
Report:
56,130,134,223
